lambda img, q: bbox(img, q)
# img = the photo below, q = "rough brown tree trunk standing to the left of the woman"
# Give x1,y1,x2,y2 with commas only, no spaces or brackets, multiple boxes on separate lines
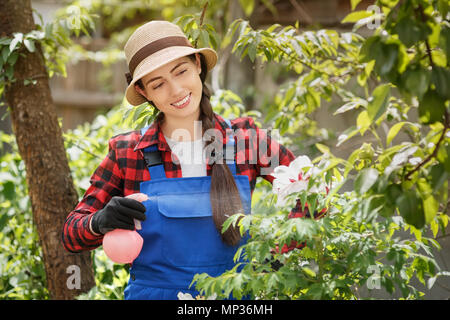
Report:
0,0,95,299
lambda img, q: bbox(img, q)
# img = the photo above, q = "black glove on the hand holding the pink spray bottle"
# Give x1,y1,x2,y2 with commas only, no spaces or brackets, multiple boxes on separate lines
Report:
91,197,146,234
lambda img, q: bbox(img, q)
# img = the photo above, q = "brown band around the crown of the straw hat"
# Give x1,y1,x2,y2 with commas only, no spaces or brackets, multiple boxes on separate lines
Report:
125,36,192,83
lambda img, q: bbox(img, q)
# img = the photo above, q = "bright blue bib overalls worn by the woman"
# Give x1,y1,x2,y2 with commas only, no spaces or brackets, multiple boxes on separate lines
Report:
124,120,251,300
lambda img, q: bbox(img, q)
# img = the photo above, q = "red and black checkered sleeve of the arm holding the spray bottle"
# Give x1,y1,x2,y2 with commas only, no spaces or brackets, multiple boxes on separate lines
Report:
62,139,123,252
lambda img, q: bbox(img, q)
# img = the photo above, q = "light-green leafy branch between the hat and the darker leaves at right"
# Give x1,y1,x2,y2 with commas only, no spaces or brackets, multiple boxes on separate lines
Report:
224,20,364,141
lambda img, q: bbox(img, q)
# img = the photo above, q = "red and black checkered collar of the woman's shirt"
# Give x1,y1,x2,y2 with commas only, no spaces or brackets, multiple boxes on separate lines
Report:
133,113,228,151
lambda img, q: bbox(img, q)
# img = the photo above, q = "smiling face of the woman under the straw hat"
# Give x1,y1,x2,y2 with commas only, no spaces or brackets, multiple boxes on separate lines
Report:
136,54,203,122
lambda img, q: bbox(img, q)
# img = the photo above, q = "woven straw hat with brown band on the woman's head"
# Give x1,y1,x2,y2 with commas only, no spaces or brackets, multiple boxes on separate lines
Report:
124,20,217,106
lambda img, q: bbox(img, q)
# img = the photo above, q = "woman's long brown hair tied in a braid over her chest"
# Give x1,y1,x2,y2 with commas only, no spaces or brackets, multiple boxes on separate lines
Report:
136,54,243,246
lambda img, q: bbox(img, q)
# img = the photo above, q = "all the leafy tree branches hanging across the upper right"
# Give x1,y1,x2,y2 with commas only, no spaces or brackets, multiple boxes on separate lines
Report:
216,0,450,229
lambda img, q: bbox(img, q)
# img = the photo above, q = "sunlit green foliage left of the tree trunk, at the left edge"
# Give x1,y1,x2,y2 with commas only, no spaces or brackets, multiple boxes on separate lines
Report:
0,131,49,300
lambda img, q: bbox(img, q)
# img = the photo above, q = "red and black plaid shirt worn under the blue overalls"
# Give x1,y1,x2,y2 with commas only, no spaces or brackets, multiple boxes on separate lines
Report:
62,114,324,252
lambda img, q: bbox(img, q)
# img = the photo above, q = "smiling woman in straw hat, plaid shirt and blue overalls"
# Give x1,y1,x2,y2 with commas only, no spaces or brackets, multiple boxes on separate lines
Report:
62,21,316,299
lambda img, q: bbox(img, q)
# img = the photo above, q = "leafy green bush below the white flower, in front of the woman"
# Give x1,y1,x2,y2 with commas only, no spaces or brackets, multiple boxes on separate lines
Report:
192,166,449,299
